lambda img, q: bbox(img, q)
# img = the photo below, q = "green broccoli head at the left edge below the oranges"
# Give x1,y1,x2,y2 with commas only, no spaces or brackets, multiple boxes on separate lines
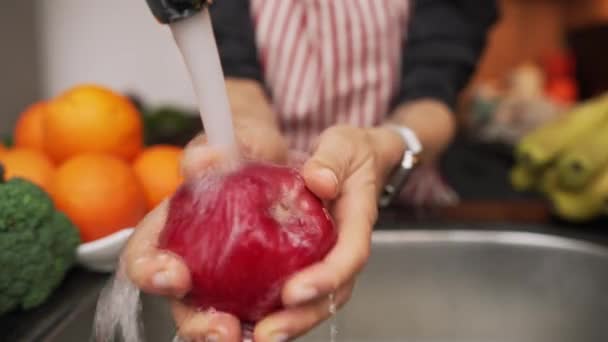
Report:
0,165,80,315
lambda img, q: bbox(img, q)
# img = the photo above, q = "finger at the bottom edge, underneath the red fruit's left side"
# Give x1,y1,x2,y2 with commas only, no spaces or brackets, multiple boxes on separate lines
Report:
171,301,242,342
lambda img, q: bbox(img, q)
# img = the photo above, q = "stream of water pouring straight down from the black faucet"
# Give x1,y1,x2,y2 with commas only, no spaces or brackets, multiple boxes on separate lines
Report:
170,8,235,147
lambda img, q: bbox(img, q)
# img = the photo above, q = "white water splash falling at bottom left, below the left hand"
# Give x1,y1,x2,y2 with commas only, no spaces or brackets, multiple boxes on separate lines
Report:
93,268,144,342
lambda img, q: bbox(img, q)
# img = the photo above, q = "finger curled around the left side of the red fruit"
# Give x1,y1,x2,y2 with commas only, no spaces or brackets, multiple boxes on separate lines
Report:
121,201,191,298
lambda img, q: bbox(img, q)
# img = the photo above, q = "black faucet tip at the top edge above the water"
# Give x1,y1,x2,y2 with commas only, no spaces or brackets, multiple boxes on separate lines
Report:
146,0,212,24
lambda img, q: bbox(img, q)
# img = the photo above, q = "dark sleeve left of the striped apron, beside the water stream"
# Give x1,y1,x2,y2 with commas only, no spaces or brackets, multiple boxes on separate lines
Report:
209,0,262,82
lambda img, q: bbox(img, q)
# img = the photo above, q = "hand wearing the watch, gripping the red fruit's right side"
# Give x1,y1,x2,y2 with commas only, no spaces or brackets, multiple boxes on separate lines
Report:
254,126,405,342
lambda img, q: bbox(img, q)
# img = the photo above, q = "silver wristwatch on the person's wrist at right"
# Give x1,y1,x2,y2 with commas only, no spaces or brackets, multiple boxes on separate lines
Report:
378,124,422,208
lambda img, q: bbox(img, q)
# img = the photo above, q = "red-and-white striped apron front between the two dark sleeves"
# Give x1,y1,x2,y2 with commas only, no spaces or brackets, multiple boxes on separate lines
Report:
251,0,409,150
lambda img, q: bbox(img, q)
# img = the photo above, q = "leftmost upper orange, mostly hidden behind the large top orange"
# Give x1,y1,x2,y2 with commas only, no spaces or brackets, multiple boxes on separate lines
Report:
15,101,48,150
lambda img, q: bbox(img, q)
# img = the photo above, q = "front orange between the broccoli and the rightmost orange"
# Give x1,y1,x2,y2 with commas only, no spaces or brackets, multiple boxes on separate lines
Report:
51,154,146,242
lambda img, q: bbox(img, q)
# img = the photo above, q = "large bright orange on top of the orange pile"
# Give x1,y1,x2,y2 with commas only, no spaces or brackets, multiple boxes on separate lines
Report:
44,85,143,161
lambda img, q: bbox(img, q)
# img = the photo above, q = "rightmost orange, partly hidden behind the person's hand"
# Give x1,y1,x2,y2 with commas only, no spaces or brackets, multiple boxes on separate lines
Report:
133,145,183,209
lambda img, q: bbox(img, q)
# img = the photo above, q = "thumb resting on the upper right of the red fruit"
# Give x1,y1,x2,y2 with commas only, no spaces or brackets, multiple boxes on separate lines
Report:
302,127,358,199
